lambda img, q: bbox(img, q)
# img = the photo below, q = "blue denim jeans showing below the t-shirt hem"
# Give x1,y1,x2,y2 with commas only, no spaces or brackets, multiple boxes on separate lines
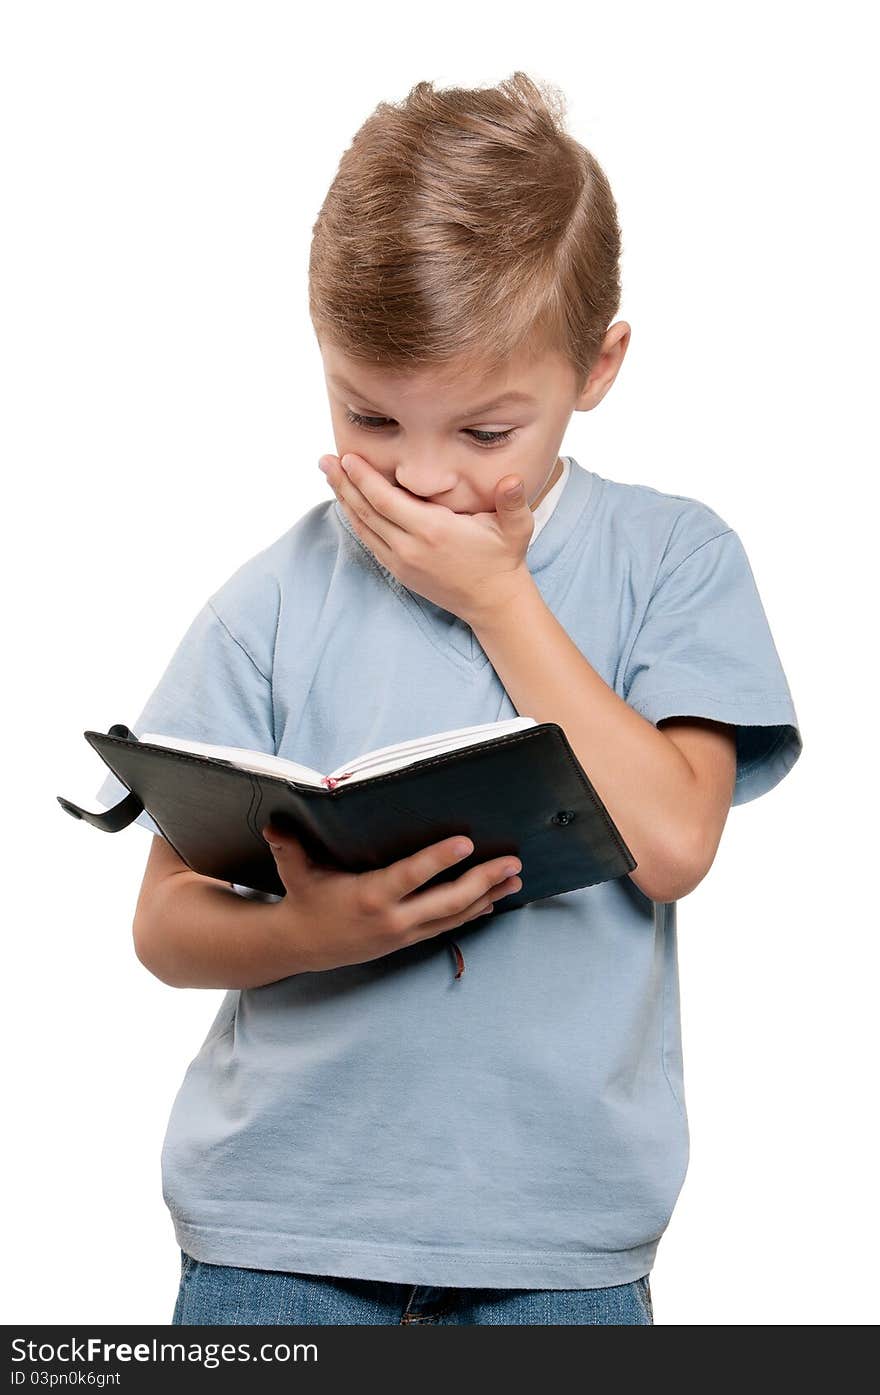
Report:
172,1250,654,1327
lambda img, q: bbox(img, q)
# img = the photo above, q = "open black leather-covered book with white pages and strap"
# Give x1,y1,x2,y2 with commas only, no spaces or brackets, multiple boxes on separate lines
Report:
57,717,636,911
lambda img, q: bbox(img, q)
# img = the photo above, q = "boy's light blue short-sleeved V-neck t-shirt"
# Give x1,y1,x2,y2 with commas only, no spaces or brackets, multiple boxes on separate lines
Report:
98,456,802,1289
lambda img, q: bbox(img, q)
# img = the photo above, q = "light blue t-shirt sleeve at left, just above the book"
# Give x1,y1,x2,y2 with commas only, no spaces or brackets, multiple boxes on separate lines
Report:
96,598,275,834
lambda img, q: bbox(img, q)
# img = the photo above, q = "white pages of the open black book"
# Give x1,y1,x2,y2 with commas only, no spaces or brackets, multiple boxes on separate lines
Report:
141,717,537,790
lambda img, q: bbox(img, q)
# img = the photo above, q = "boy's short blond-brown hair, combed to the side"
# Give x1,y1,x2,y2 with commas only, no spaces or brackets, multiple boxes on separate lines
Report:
308,71,621,384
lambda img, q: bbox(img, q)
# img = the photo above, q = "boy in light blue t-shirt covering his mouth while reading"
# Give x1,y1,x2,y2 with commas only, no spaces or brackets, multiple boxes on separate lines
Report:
92,73,801,1324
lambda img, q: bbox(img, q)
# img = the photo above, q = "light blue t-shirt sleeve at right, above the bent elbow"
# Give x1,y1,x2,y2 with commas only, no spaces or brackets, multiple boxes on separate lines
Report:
623,529,802,805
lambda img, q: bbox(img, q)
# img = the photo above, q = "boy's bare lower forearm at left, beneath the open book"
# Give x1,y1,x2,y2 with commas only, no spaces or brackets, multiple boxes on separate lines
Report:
134,872,303,988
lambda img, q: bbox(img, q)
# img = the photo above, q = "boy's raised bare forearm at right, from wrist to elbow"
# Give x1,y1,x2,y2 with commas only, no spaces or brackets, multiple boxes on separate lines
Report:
470,576,697,901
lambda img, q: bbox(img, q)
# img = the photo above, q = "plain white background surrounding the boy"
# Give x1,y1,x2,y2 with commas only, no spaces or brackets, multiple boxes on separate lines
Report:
0,0,879,1325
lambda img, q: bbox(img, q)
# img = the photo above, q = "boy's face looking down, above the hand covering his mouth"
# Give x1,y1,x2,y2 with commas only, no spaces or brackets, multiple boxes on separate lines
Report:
321,321,630,513
